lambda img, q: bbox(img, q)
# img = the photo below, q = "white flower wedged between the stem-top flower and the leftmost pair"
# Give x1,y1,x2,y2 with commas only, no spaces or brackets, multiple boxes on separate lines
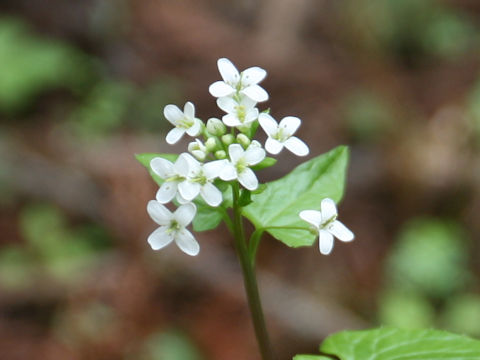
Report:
178,154,227,206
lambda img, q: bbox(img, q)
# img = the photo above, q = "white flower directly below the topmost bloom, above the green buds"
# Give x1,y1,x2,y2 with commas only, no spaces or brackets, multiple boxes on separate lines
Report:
217,96,258,127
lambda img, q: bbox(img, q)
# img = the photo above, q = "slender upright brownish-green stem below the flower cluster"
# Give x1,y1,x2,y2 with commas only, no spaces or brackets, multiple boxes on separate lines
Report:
232,183,273,360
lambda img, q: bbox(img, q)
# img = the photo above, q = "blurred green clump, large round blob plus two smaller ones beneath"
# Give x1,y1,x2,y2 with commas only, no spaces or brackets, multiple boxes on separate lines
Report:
379,218,480,336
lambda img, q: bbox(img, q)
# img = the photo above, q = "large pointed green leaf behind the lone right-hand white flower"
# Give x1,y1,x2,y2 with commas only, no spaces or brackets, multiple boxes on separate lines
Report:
243,146,348,247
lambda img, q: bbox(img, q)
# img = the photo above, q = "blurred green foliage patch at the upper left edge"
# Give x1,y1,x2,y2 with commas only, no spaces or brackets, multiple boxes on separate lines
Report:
0,17,93,114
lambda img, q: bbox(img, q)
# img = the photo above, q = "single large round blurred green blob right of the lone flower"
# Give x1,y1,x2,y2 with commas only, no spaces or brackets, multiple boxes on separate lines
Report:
387,218,471,298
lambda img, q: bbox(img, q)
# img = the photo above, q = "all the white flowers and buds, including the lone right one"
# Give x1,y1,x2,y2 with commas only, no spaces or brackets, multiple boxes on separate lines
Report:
147,58,352,255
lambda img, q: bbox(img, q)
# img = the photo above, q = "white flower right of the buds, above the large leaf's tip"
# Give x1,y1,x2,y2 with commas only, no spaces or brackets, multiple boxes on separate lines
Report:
258,113,309,156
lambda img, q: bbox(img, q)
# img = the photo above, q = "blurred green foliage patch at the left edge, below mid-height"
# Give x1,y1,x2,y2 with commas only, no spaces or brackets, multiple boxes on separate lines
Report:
0,204,110,289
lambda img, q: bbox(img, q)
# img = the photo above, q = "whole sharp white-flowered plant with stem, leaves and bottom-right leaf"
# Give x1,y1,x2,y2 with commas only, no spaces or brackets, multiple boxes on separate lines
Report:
137,58,480,360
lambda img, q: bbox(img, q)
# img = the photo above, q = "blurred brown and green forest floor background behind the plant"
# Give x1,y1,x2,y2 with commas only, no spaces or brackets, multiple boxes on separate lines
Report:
0,0,480,360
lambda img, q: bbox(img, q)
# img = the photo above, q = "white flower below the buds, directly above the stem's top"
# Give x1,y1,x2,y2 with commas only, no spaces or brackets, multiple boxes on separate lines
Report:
220,144,265,190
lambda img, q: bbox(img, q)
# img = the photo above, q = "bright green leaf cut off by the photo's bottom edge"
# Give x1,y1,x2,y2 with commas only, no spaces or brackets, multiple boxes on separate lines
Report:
314,327,480,360
